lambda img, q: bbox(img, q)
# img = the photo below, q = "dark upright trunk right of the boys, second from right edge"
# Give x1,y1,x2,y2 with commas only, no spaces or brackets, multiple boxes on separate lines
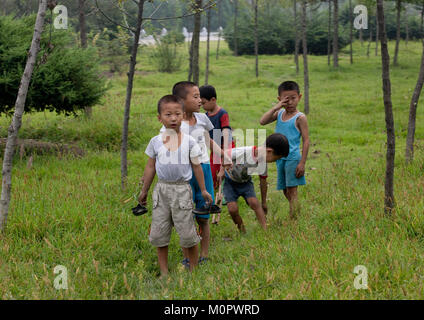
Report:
377,0,396,215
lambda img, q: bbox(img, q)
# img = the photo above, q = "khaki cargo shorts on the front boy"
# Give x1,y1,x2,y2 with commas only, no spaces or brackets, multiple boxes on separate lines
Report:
149,181,200,248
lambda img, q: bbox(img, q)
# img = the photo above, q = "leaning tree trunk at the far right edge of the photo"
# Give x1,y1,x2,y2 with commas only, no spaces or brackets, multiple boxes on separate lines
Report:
405,40,424,163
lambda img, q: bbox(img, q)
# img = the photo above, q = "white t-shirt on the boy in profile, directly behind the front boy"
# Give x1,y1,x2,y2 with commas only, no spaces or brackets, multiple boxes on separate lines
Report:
160,113,215,163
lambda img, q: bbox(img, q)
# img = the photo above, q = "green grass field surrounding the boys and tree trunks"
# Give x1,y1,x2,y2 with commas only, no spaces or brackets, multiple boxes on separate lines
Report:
0,42,424,299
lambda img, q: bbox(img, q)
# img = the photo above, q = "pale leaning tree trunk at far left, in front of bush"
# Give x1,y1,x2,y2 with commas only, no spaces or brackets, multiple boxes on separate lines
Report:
0,0,47,231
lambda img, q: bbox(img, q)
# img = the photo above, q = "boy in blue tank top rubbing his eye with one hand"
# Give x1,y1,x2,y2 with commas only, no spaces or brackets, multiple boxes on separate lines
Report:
261,81,309,219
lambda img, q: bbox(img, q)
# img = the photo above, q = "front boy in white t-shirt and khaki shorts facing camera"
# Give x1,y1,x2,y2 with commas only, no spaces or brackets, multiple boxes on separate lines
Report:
138,95,212,276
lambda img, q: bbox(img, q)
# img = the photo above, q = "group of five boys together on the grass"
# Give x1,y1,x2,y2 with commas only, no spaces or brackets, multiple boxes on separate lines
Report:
138,81,309,275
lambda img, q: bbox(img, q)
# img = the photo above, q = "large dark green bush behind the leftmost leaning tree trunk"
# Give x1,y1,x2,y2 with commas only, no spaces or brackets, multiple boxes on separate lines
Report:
0,16,106,115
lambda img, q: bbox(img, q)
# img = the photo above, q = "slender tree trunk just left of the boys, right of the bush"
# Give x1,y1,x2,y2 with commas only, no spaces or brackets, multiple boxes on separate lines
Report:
121,0,144,189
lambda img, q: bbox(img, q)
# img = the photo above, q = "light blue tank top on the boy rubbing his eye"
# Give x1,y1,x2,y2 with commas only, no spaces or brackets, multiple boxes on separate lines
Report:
275,109,303,160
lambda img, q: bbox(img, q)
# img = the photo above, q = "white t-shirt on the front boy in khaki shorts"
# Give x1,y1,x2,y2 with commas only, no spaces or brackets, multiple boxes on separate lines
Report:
146,133,202,182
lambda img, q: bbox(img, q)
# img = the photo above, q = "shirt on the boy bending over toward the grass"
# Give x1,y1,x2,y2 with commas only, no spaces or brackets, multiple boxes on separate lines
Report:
225,147,268,183
